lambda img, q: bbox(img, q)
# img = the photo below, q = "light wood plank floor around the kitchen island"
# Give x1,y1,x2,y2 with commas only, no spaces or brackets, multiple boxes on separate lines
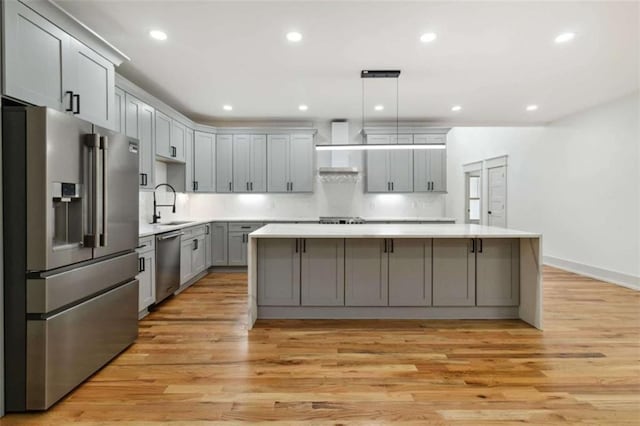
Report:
0,268,640,425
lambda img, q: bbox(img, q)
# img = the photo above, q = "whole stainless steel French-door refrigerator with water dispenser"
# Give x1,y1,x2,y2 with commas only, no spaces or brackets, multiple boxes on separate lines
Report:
2,107,138,411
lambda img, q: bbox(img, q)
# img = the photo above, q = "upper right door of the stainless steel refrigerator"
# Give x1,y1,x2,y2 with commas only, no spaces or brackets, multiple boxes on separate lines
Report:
94,127,139,258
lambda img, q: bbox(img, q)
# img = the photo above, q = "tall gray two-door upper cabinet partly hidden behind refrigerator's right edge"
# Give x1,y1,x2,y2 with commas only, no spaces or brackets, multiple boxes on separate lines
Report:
125,93,156,189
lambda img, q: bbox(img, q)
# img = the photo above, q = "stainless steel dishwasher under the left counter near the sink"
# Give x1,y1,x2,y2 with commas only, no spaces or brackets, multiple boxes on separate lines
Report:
156,232,184,303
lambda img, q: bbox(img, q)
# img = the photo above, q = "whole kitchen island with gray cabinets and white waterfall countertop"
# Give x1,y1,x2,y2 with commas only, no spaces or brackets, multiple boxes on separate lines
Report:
248,224,542,329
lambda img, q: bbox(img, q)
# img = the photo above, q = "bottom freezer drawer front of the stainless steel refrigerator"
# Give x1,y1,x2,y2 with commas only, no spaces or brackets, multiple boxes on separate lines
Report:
26,280,138,410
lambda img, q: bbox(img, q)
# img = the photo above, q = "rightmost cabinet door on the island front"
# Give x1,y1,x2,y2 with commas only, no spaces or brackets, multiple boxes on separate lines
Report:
476,238,520,306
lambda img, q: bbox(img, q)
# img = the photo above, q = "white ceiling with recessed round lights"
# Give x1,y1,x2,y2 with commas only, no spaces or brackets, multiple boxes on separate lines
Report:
58,0,640,125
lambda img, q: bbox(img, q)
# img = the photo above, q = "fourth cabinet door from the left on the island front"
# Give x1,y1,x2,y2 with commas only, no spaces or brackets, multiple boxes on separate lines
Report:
388,238,431,306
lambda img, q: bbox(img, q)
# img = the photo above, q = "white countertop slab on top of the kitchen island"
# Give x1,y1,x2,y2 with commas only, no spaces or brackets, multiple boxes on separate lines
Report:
249,223,541,238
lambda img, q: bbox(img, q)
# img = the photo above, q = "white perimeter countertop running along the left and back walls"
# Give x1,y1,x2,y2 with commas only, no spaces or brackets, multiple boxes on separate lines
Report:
138,217,455,237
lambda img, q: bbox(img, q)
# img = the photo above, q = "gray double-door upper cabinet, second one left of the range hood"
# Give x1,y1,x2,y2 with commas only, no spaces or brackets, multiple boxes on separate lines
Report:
233,135,267,192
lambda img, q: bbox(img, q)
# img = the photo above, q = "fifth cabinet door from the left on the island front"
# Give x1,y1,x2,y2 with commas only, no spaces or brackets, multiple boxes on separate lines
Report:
433,238,476,306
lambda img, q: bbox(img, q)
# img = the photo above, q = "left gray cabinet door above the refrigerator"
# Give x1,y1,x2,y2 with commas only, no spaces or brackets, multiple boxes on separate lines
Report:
2,1,72,111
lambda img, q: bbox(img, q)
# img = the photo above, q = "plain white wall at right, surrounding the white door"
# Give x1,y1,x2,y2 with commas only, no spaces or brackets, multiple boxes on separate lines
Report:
446,92,640,285
